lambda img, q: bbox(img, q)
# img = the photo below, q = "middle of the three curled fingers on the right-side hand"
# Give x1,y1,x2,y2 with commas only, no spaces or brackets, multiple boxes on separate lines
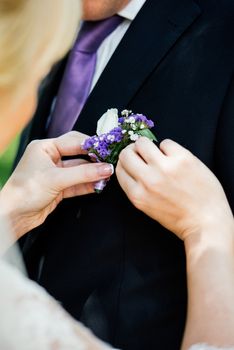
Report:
119,144,146,181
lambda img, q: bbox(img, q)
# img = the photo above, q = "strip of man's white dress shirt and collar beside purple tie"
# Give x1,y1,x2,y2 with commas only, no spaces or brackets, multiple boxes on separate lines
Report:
91,0,146,91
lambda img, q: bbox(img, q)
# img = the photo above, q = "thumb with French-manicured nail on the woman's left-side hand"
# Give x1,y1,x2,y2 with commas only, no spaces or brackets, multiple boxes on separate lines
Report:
54,163,113,191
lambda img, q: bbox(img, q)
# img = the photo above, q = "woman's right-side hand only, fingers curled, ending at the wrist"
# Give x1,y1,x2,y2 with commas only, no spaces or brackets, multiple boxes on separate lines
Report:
116,138,233,240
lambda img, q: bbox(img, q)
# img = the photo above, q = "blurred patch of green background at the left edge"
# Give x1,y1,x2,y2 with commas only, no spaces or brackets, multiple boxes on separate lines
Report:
0,136,20,188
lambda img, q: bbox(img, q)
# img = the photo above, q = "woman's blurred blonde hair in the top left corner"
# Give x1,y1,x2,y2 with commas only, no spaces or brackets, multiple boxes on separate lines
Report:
0,0,80,97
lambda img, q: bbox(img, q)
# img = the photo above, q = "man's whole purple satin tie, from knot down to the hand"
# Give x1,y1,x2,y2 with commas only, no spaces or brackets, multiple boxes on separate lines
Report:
48,15,123,137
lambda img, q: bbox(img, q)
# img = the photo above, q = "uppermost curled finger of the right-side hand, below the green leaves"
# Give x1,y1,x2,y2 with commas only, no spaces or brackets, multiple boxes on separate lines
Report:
135,137,164,164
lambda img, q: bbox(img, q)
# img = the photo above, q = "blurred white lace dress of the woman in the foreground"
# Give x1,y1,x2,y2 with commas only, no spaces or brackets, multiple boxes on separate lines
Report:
0,220,233,350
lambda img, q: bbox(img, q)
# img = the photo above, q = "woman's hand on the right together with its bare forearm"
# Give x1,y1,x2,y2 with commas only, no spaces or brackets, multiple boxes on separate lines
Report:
116,138,234,350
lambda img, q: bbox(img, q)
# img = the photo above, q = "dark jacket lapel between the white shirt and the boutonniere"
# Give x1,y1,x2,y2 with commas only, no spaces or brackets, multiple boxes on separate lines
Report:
74,0,201,134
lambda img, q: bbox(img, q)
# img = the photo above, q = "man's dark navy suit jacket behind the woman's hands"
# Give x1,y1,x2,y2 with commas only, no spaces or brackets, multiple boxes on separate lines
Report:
20,0,234,350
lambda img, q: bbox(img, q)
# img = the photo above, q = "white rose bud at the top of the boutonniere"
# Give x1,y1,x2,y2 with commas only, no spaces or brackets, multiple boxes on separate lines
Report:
97,108,119,136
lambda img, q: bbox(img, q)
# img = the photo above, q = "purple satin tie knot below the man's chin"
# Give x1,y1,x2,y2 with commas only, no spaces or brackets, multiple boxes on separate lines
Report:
74,15,123,53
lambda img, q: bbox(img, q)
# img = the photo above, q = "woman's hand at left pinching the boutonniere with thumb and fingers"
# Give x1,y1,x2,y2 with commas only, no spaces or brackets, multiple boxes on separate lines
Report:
0,131,113,238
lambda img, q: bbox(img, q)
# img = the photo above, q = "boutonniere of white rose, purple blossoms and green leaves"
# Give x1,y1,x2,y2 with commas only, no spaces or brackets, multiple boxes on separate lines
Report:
82,108,157,193
